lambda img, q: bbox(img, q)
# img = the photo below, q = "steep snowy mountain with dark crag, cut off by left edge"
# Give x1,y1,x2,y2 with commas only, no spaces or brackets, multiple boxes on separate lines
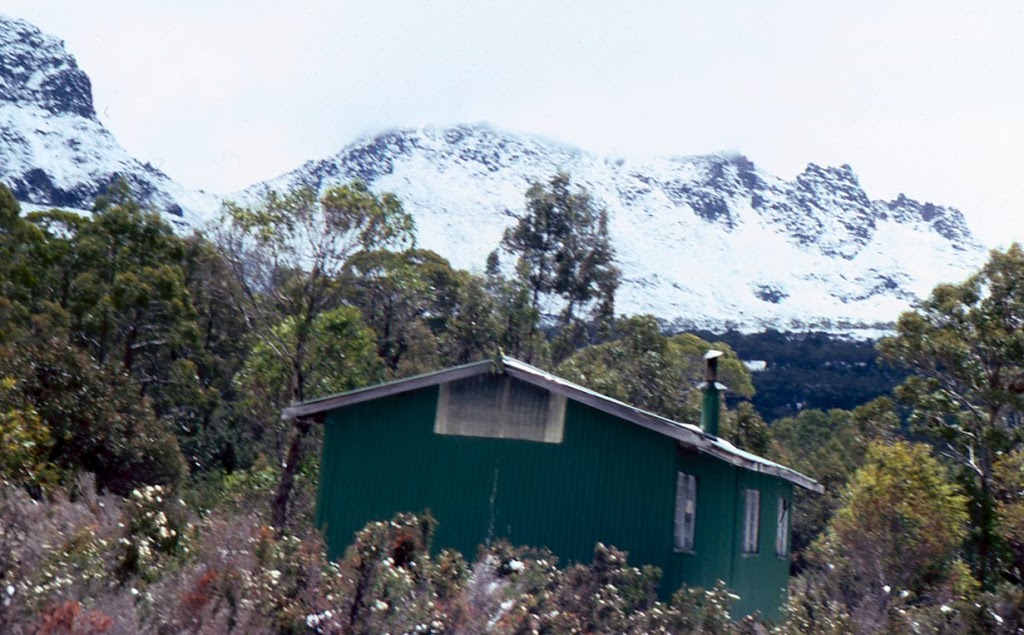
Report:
0,15,217,217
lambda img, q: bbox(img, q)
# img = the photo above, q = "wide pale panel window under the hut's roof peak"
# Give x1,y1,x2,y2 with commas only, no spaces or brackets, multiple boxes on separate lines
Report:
434,375,565,443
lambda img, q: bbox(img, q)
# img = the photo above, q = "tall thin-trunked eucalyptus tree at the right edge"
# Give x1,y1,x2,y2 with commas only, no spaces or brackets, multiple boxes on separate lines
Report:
880,244,1024,583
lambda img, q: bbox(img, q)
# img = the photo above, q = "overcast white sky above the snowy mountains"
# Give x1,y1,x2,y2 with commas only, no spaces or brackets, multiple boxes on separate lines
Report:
6,0,1024,246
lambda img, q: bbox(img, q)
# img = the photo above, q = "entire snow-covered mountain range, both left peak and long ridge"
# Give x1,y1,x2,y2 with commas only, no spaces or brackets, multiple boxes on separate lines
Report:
0,15,984,335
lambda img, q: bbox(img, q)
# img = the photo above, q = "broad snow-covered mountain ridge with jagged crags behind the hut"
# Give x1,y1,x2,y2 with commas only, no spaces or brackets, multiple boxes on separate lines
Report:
244,126,985,335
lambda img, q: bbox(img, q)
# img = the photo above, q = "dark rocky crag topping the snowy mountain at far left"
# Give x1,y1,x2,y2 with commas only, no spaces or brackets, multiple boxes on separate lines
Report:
0,15,96,119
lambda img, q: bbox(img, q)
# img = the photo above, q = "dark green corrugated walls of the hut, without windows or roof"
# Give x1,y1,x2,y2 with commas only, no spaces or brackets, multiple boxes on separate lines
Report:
317,378,792,616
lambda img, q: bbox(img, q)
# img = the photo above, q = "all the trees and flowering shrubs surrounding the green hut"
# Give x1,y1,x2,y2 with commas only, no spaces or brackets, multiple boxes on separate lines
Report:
0,174,1024,633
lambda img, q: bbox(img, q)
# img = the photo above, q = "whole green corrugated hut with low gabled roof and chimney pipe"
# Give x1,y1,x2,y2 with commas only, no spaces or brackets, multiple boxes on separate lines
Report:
284,352,821,618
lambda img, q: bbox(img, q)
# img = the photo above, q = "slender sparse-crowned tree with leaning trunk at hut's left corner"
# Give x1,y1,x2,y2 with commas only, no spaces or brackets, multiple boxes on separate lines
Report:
213,181,414,531
